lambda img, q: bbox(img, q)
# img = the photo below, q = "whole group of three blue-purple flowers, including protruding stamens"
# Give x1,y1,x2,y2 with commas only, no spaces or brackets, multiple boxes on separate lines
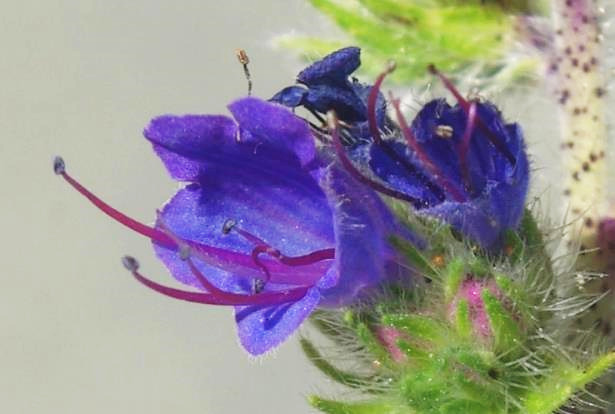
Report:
54,48,528,355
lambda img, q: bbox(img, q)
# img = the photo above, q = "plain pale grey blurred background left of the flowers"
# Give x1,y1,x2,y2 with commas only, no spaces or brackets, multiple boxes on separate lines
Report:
0,0,342,414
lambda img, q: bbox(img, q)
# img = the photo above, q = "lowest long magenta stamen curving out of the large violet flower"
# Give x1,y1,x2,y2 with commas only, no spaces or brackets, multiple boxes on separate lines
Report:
122,256,309,306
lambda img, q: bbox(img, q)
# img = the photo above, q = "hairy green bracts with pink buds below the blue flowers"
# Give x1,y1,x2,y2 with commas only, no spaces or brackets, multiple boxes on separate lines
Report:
302,213,615,414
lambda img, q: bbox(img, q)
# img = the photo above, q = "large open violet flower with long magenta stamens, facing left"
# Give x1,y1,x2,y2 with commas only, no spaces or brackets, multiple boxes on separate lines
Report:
55,98,410,355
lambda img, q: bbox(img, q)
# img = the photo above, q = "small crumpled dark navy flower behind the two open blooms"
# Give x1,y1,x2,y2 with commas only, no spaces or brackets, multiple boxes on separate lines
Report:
270,47,386,138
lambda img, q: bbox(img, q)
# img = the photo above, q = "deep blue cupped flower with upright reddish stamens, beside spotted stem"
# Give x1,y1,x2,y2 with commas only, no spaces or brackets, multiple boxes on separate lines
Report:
334,64,529,249
